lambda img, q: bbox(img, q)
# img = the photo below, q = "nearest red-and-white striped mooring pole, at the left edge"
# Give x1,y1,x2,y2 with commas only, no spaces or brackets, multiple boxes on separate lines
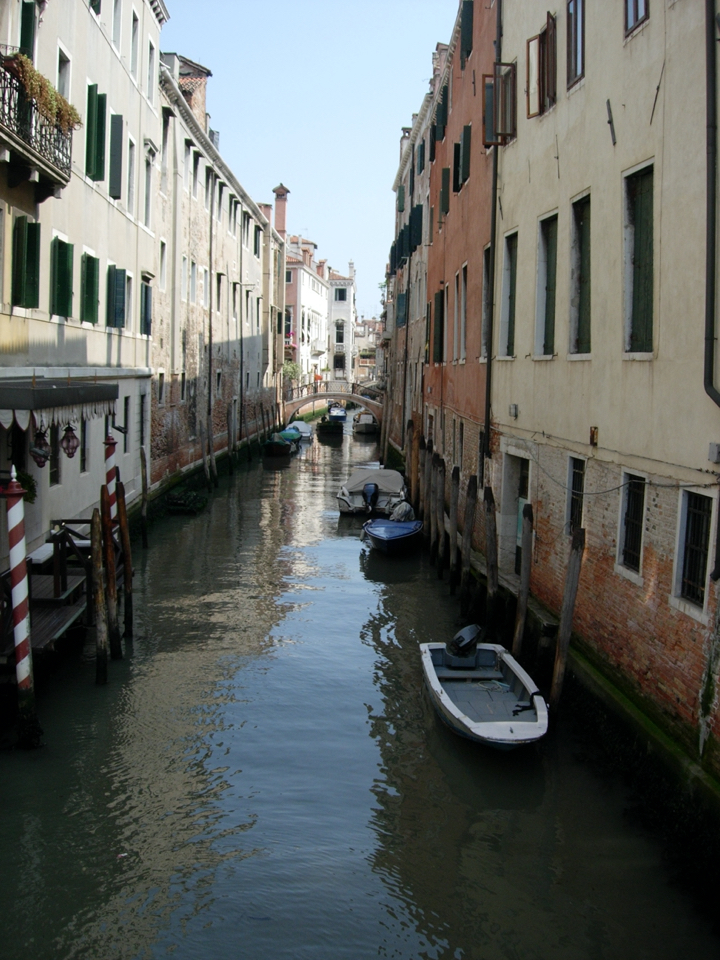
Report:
5,466,42,747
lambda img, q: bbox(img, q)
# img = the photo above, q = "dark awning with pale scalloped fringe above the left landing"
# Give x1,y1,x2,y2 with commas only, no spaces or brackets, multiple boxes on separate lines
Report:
0,378,118,430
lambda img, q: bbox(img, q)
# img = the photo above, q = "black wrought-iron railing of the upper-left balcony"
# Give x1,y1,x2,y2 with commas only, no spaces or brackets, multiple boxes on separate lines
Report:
0,58,72,180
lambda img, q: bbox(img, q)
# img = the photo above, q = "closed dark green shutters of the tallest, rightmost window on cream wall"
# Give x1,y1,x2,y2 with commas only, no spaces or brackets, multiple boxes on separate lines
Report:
628,168,653,353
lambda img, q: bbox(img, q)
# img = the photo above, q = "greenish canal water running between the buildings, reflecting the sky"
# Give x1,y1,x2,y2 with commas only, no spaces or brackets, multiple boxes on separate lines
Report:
0,436,720,960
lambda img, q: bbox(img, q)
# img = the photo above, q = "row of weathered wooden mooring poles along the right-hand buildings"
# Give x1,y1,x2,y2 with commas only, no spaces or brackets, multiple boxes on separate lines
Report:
406,421,585,709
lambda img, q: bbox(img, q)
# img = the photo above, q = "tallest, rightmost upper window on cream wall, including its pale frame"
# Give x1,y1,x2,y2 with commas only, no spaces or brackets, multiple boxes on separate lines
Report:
625,167,653,353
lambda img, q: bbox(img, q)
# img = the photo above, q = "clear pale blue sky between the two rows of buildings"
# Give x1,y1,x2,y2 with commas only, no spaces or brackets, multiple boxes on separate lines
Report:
161,0,458,316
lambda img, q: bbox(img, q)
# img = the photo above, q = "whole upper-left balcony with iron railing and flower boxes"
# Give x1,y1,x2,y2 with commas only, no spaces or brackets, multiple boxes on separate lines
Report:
0,48,72,203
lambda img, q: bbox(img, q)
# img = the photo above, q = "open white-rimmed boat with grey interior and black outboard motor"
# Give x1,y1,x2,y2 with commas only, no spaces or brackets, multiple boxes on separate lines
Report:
420,624,548,750
